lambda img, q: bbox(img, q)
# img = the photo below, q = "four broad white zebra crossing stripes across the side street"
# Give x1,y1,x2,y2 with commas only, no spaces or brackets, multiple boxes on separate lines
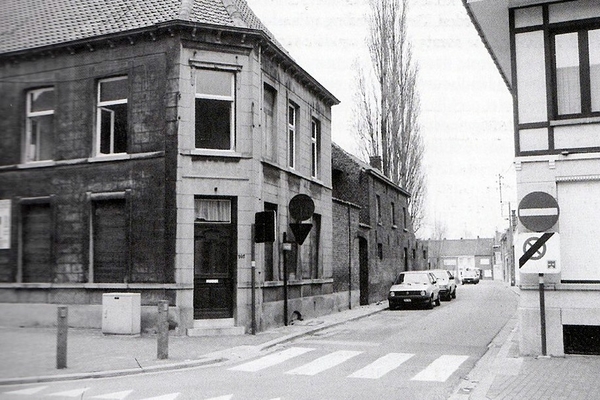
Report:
229,347,469,382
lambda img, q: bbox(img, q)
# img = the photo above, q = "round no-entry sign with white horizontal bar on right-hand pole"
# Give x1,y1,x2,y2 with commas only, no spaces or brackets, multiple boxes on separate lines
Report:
518,192,559,232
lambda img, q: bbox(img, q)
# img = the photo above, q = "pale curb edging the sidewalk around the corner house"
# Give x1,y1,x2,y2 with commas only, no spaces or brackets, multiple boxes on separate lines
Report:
0,306,387,386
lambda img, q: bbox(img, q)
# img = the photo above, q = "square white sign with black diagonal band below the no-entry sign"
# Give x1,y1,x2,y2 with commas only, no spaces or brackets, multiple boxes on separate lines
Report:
515,232,560,274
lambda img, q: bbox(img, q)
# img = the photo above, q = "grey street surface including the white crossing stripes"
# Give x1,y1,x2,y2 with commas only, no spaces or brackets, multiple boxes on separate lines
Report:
0,281,517,400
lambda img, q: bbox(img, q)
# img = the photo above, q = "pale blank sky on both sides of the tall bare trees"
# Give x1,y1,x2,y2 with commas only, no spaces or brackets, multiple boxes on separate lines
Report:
247,0,517,239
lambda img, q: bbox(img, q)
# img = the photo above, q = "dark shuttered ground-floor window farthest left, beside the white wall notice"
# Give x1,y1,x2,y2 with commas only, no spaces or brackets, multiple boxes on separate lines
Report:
21,203,54,282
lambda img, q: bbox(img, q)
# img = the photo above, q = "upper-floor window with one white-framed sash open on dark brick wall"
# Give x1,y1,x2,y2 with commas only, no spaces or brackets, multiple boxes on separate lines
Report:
96,76,129,154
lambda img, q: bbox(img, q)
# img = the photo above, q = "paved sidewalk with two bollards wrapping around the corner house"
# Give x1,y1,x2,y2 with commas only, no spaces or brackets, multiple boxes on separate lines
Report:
0,302,387,385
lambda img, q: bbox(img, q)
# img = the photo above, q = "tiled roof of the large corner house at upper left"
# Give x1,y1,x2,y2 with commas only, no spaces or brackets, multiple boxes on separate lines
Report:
0,0,281,54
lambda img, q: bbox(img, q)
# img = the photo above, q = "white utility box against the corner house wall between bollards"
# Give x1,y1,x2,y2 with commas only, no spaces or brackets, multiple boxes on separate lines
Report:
102,293,142,335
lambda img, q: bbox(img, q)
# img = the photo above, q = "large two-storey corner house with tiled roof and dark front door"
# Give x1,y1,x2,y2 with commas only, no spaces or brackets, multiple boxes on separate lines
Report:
0,0,338,334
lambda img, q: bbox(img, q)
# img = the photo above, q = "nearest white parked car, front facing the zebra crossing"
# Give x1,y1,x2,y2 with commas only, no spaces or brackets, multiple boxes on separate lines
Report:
388,271,440,310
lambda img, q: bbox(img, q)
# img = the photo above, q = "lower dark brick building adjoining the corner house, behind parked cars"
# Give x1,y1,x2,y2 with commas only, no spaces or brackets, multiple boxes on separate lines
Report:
331,143,426,304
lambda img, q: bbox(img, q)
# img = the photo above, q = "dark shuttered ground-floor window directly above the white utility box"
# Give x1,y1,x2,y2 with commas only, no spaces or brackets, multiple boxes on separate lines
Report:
90,198,130,283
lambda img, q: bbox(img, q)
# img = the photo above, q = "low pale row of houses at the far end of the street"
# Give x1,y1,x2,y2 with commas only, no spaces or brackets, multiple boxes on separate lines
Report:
426,237,495,279
